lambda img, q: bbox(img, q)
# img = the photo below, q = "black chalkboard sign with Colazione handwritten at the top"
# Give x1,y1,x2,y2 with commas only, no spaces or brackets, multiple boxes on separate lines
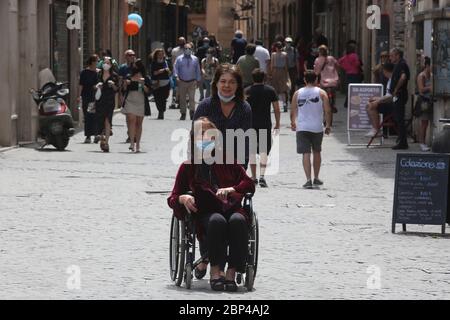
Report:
392,154,450,233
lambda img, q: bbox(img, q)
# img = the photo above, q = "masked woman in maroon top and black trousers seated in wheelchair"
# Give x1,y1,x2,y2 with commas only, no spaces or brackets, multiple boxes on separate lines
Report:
168,118,255,292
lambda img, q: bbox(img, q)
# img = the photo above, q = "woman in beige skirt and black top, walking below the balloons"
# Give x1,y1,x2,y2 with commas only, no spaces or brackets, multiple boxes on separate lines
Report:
122,59,152,153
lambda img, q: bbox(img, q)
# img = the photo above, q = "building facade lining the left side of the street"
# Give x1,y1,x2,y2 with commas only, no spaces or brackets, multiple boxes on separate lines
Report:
0,0,187,147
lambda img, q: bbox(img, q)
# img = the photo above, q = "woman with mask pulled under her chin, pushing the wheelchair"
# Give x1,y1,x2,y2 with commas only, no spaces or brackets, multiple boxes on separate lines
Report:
194,64,252,169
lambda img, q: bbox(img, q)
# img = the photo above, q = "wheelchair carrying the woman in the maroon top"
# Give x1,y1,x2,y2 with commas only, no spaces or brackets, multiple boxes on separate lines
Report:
170,194,259,292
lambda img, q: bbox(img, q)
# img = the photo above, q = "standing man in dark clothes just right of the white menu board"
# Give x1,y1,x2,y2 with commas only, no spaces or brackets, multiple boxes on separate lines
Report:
390,48,411,150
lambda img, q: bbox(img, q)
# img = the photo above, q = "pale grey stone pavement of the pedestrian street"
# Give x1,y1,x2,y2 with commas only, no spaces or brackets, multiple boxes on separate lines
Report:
0,94,450,300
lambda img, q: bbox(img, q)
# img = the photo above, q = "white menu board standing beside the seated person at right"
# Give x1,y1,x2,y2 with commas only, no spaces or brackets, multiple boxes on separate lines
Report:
348,84,384,131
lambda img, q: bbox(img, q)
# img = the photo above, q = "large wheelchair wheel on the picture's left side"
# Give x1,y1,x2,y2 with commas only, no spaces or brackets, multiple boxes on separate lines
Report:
170,217,186,287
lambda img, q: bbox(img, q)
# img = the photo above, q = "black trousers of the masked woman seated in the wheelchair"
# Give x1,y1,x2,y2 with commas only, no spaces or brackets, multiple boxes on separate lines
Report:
200,213,248,273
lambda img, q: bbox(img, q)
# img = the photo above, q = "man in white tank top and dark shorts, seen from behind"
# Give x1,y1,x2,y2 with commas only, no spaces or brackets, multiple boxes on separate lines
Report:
291,70,332,189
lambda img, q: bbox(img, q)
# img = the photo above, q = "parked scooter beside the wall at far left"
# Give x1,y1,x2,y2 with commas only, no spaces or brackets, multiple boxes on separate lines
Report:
30,69,75,151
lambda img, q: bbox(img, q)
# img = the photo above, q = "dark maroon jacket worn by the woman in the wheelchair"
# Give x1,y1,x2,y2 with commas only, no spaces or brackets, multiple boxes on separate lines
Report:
168,163,255,220
